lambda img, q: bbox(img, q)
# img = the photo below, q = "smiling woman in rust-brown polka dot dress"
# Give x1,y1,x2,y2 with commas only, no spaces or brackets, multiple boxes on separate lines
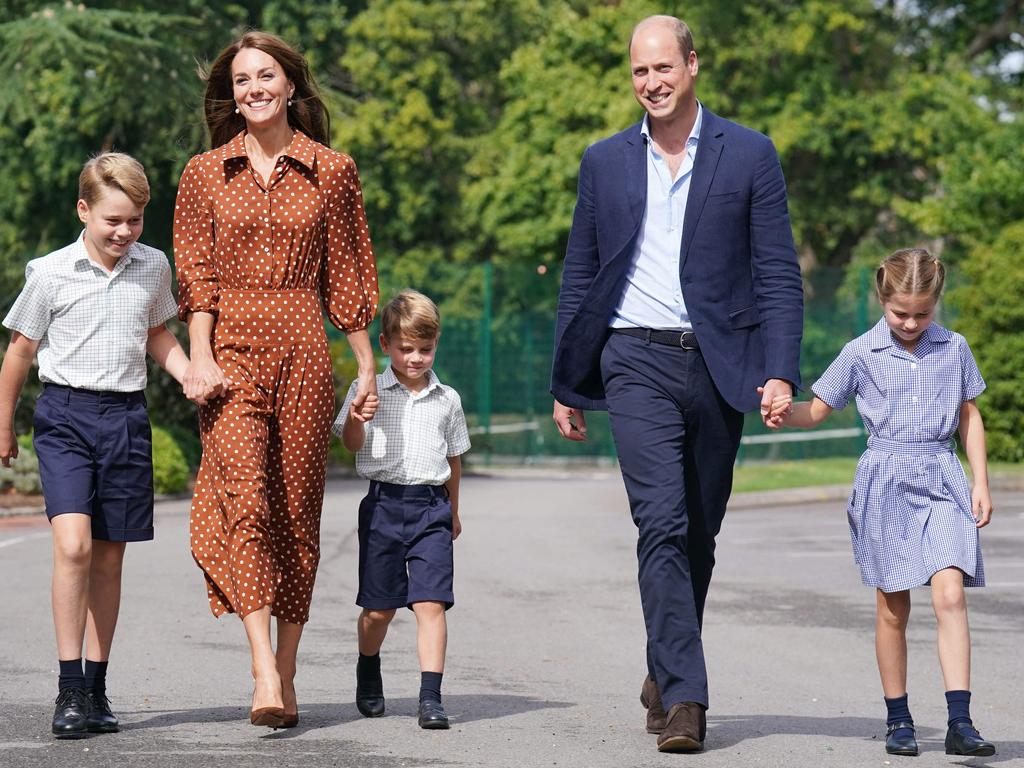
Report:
174,32,378,727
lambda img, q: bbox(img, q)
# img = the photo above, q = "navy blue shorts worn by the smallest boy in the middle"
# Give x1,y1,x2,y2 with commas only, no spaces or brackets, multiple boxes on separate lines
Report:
355,480,455,610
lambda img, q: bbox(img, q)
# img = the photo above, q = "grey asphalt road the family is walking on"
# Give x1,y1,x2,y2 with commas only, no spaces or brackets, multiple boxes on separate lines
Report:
0,479,1024,768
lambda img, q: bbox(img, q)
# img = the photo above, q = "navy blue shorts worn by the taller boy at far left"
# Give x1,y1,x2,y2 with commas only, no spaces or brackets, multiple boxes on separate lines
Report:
32,384,153,542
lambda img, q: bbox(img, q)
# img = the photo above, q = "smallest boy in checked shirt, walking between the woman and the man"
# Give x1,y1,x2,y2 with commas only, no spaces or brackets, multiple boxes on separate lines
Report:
335,290,469,729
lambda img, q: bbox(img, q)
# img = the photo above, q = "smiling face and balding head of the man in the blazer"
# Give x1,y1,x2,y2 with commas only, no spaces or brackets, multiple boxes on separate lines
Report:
630,24,697,122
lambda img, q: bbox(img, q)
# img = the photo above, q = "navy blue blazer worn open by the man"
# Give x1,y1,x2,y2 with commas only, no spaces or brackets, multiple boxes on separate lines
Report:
551,108,804,412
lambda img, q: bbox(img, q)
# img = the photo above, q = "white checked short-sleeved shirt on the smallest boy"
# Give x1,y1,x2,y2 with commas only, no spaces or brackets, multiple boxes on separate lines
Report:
334,366,469,485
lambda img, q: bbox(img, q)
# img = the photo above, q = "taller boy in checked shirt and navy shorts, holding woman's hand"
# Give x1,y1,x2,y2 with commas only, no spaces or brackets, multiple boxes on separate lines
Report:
0,153,188,738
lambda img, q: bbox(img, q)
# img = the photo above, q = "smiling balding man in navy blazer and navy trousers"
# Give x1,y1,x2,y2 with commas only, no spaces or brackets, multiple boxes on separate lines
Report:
551,16,803,752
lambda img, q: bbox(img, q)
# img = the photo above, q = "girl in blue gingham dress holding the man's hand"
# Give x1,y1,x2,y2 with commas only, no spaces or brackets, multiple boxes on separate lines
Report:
772,249,995,756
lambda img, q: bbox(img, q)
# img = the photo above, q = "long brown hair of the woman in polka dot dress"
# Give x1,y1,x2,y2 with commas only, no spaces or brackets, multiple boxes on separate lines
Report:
201,30,331,148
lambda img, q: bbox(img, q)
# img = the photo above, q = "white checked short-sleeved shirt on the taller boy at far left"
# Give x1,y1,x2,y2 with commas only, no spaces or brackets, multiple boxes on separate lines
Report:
3,232,177,392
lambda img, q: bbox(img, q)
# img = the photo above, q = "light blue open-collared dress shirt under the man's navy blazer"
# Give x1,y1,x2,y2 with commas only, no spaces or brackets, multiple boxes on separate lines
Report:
609,102,703,328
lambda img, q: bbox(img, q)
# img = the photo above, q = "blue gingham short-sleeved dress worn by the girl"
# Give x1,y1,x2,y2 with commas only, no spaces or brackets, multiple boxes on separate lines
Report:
811,317,985,592
